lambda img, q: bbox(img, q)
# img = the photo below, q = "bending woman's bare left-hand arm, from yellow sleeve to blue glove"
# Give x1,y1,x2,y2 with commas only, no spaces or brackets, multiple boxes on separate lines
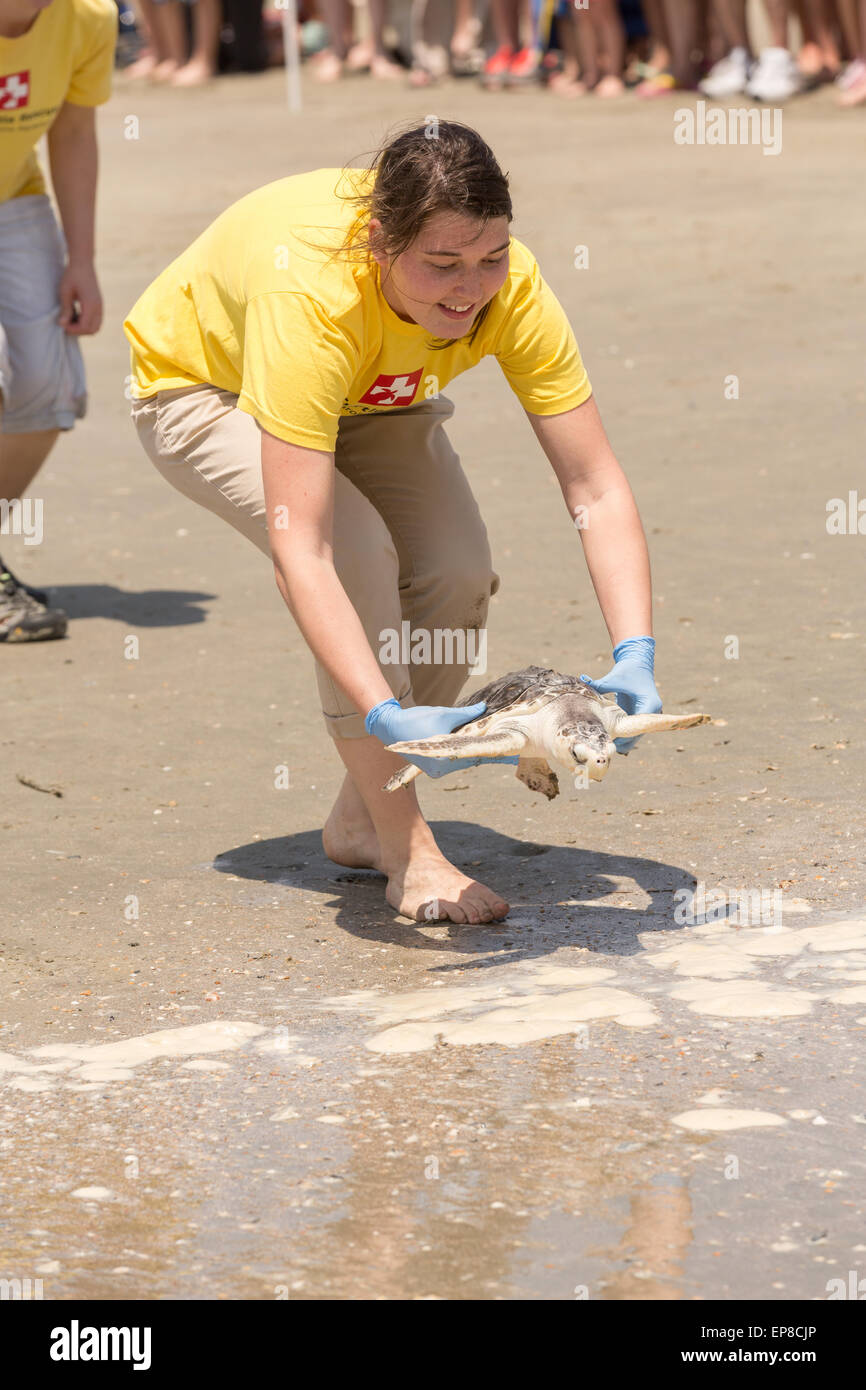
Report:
261,430,392,714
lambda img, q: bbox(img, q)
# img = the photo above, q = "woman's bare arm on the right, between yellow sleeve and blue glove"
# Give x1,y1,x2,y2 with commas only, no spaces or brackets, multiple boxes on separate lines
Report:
527,396,652,646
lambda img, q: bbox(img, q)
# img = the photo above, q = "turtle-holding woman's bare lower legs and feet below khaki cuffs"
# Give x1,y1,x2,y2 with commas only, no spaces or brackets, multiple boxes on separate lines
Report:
322,738,509,924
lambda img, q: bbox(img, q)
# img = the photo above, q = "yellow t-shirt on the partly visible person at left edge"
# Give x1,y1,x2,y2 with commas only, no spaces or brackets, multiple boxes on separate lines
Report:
0,0,117,203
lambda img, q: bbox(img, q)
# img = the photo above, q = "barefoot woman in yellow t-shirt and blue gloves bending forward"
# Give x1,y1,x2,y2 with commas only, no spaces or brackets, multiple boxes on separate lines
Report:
124,118,662,923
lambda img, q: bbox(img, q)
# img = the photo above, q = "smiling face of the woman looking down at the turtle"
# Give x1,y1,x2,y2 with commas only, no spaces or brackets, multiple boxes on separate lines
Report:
370,213,509,338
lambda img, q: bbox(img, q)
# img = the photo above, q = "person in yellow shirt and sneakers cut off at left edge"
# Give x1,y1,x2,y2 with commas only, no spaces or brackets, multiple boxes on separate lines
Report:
0,0,117,642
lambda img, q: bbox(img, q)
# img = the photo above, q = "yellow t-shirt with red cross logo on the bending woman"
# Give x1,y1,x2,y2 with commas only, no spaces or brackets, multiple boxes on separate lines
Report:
124,170,591,452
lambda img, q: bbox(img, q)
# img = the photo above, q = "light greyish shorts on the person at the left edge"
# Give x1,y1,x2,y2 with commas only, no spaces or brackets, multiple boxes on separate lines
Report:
0,193,88,434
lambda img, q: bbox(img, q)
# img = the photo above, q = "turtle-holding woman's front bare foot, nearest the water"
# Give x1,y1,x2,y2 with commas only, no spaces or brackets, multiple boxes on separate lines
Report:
385,845,509,926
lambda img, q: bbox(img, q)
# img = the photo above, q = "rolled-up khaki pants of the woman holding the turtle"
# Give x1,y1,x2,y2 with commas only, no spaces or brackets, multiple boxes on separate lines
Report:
132,386,499,738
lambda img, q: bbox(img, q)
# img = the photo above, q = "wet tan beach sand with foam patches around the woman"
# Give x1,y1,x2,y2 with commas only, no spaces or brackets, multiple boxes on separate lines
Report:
0,74,866,1301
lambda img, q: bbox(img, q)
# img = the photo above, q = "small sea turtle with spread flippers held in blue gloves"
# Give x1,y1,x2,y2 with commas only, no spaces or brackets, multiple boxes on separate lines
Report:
385,666,710,801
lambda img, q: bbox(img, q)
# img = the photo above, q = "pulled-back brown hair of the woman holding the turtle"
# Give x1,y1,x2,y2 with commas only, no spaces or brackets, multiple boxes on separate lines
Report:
301,117,513,350
